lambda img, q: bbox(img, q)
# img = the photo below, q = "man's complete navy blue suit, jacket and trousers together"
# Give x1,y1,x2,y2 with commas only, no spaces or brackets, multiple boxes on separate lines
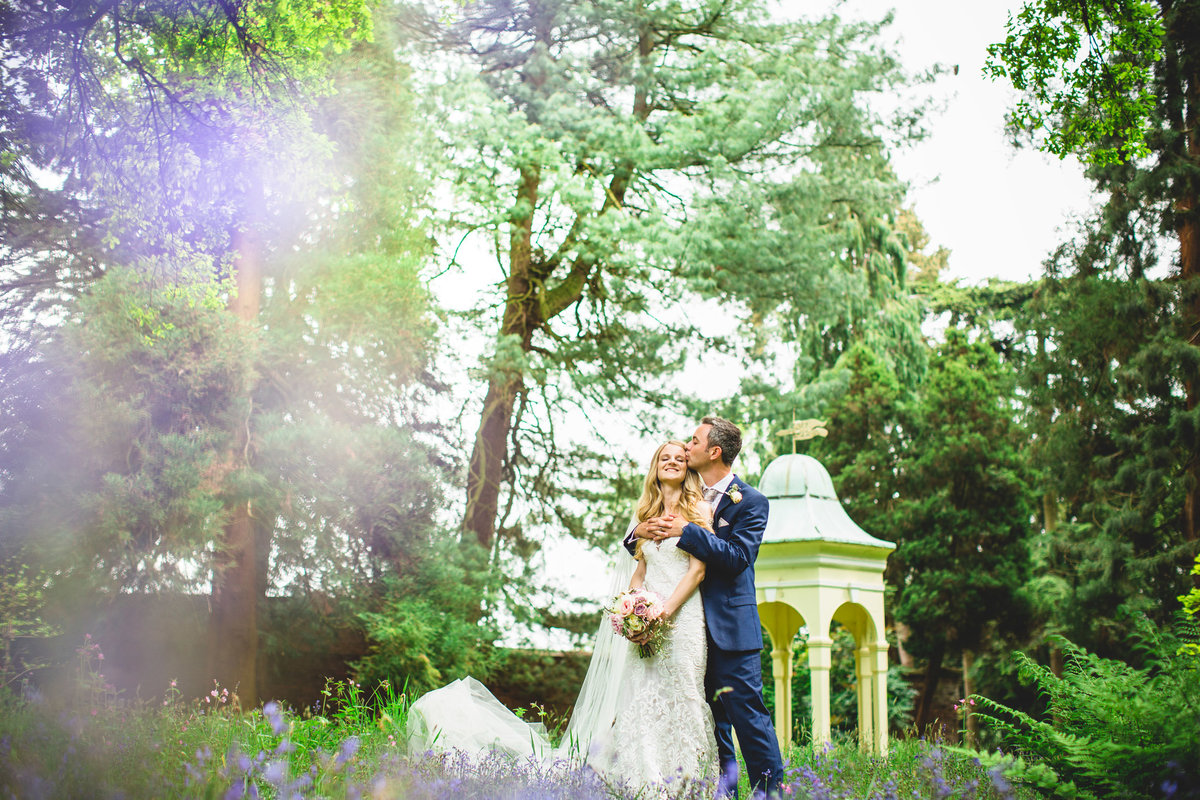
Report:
626,475,784,793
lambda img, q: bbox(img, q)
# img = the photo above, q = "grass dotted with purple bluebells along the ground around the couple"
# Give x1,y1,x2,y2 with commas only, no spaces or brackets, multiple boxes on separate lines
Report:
0,651,1034,800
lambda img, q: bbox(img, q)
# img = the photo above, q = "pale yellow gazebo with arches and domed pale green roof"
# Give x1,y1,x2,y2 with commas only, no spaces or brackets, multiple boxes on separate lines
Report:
755,453,895,754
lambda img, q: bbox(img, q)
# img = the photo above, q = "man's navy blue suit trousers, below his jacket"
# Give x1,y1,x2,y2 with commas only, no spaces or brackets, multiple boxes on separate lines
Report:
704,636,784,798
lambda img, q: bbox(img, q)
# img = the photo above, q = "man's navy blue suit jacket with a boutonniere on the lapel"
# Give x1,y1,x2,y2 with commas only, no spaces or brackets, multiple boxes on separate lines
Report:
679,475,770,650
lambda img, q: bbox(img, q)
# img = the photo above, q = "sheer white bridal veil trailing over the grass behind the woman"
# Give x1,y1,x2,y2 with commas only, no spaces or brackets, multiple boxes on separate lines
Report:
408,548,634,771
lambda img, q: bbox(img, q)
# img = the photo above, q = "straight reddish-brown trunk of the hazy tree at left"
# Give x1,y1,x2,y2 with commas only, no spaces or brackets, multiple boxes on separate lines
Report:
209,196,265,708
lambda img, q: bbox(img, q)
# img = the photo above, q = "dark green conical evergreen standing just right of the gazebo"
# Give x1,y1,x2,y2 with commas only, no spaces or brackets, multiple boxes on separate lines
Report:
888,329,1032,730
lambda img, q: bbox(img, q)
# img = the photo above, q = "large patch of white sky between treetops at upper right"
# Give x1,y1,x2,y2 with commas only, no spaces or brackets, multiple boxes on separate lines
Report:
839,0,1091,283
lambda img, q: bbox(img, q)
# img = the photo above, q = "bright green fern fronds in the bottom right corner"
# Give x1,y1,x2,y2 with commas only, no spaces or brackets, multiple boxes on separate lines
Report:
976,620,1200,800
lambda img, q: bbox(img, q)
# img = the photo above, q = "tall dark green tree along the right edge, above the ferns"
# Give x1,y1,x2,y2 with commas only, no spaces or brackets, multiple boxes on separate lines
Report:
989,0,1200,652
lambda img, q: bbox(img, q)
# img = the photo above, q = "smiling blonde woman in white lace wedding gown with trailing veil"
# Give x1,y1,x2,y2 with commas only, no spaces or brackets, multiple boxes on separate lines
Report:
408,441,718,787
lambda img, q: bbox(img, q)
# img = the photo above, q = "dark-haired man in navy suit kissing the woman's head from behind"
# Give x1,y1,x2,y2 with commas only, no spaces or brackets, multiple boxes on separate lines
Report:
625,416,784,798
